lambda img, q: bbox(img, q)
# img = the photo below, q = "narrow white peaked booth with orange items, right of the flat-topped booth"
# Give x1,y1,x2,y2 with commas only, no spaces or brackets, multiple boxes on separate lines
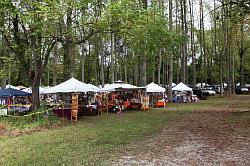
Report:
146,82,166,107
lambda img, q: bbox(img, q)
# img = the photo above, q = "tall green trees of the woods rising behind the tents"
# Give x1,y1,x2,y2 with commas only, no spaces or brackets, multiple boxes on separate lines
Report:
0,0,250,108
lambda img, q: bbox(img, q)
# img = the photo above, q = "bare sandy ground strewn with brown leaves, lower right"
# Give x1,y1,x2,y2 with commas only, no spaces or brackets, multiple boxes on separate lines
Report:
109,110,250,166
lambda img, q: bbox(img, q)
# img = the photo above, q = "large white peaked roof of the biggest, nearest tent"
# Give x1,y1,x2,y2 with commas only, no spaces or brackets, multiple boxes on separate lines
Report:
45,78,97,93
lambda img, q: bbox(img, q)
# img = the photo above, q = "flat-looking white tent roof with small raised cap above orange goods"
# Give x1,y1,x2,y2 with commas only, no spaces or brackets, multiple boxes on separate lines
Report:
100,83,141,92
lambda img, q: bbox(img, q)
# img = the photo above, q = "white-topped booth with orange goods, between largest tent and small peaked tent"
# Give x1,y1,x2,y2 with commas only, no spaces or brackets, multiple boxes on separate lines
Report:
100,82,149,112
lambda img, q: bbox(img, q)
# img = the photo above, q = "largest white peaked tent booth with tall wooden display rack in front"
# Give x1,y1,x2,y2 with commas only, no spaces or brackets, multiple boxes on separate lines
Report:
45,78,99,120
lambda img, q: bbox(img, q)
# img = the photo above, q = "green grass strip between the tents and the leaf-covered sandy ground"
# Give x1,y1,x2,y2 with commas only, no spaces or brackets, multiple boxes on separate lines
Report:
0,96,250,166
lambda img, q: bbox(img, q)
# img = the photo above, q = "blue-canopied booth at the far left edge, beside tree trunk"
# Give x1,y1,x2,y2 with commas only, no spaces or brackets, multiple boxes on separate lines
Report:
0,88,32,115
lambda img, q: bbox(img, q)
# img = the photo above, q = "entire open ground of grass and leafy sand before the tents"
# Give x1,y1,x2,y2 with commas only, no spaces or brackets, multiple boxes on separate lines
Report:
0,95,250,166
